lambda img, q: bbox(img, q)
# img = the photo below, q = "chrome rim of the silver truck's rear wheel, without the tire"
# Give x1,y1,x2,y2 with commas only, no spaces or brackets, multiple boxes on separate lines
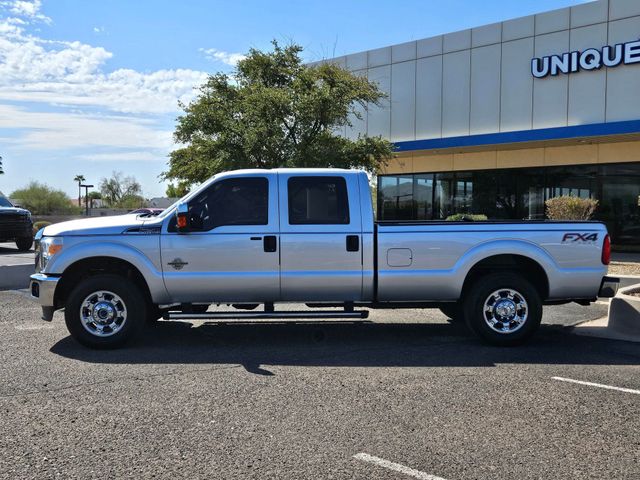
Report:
483,288,529,333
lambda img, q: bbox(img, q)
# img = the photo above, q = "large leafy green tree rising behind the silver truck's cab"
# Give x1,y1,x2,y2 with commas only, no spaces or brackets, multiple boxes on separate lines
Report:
163,41,393,184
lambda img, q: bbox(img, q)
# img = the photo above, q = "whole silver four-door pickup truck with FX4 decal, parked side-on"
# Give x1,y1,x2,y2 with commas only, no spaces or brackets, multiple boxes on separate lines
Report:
31,169,617,348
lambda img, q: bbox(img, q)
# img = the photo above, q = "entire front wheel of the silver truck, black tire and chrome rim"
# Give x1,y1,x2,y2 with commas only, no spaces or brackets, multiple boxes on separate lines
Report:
64,274,147,349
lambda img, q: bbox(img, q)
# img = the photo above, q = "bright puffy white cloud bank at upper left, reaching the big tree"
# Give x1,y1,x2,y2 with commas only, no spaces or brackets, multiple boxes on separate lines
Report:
0,9,207,114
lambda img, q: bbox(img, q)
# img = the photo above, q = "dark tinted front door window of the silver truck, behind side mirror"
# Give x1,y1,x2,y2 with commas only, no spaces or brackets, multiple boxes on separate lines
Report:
189,177,269,231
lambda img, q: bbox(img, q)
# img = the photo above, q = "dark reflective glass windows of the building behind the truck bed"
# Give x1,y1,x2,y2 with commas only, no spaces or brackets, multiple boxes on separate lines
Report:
378,163,640,249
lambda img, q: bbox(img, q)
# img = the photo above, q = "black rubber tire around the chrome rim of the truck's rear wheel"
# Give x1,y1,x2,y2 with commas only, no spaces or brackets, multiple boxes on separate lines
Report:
465,272,542,346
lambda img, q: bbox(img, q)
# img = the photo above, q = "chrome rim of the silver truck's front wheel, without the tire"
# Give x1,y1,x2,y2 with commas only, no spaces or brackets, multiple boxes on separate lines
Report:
80,290,127,337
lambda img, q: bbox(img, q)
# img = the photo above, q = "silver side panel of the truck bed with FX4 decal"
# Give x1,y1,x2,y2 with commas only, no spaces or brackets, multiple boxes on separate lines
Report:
378,222,607,301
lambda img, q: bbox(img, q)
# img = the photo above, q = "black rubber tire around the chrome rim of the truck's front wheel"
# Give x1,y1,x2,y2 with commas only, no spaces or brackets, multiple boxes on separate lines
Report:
64,274,147,349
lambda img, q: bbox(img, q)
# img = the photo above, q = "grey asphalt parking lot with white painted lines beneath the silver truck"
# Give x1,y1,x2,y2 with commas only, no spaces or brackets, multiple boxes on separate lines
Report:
0,292,640,480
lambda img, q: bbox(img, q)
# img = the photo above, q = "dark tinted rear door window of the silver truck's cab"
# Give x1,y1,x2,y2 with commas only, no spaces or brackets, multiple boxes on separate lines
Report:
287,177,349,225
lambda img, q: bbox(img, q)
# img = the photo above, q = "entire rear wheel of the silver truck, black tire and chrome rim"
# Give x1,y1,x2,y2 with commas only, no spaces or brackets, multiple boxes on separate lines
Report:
464,272,542,346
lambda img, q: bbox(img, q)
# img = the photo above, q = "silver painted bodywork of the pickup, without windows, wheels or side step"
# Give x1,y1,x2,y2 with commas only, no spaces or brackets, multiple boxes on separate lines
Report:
33,169,607,307
